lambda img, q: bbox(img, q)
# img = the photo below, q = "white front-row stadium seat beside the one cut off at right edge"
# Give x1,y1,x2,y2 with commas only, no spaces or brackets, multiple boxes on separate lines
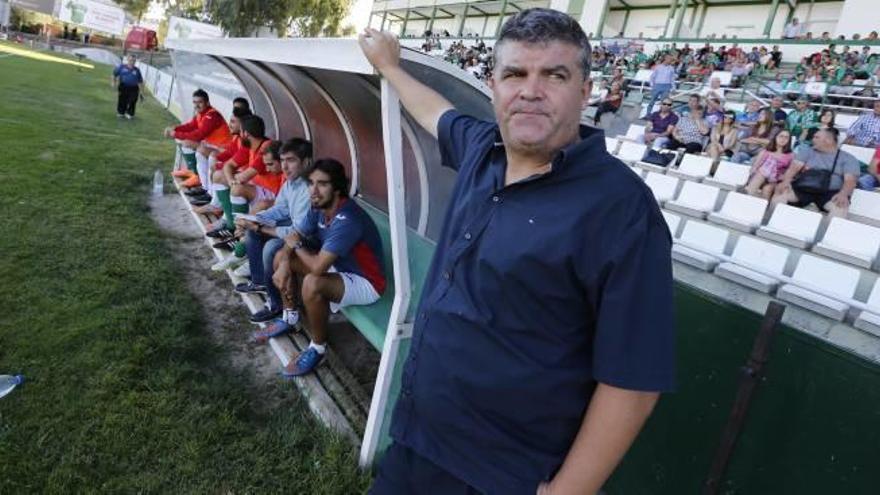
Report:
776,254,860,321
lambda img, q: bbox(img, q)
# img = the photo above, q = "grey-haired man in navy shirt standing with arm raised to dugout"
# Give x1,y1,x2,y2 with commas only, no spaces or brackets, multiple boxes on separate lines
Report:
360,9,674,495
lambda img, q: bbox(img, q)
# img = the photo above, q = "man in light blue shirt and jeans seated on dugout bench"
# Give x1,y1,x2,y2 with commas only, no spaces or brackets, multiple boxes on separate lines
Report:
235,138,312,322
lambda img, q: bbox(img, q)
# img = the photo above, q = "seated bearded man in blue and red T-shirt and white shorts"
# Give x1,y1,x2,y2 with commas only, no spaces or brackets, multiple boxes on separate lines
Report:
270,159,386,377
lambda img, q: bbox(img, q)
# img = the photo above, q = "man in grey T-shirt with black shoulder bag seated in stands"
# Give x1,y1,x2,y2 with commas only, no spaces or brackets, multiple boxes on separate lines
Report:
771,128,859,217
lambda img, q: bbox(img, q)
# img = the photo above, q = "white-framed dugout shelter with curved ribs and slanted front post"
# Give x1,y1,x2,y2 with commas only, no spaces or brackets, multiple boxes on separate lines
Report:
168,38,494,468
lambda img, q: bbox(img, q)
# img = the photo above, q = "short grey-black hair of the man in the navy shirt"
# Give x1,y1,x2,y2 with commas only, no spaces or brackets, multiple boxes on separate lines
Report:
494,8,592,79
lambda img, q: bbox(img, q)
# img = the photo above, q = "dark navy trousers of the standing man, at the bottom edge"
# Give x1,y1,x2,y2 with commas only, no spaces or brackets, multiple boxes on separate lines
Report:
369,442,480,495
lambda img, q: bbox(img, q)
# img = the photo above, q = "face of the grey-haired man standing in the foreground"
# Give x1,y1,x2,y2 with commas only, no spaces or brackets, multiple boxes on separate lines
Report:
489,41,591,155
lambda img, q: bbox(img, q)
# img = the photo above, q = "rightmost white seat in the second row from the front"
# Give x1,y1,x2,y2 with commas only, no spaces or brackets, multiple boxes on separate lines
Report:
813,218,880,269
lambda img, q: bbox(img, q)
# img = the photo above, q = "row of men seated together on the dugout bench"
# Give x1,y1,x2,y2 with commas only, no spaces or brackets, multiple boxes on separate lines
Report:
165,89,386,377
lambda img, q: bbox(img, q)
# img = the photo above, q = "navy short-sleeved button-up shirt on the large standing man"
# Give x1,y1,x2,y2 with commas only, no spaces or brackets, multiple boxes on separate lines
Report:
391,110,674,495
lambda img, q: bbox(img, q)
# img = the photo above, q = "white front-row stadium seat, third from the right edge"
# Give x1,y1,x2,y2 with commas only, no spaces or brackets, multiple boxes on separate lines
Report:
715,235,791,294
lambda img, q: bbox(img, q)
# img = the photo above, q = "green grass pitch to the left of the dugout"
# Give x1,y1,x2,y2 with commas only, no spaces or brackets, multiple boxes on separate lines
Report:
0,44,369,494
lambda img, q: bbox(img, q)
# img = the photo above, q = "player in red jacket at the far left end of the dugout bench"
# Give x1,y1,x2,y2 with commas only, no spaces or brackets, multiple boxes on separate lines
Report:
165,89,232,192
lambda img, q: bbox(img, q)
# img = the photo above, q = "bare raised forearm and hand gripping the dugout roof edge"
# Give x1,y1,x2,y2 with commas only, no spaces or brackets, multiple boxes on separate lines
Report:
358,28,454,137
